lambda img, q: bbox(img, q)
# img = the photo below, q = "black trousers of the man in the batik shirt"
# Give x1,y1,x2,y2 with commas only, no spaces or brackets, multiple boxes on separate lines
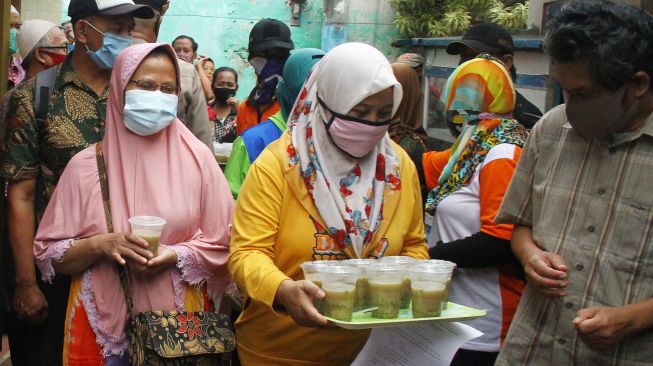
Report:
3,240,70,366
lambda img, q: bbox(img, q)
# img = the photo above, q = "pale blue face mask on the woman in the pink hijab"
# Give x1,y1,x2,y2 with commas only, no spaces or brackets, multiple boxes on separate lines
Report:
124,89,179,136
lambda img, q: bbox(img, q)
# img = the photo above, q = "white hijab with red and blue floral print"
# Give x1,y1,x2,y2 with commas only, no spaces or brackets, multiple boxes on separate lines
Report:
288,43,402,258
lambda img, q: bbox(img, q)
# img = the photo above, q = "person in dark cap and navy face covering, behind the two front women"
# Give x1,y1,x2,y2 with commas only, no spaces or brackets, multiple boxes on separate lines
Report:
236,18,295,134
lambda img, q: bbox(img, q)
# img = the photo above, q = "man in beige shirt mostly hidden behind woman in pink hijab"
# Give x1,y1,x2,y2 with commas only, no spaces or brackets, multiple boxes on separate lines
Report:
132,0,213,151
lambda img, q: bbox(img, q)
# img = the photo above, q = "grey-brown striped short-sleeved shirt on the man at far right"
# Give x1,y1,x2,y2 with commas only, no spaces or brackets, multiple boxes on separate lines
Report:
496,106,653,365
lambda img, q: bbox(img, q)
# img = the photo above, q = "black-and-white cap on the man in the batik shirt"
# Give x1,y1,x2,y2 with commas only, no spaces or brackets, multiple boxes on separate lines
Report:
68,0,154,20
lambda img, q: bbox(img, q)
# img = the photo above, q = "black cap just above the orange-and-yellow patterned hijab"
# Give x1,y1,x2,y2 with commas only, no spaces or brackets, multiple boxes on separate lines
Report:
447,23,514,55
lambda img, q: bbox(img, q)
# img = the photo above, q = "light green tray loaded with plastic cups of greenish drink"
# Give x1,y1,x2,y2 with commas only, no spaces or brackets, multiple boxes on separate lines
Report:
302,256,486,329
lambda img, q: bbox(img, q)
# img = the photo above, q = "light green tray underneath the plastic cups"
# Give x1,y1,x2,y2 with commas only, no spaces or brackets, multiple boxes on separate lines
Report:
326,302,487,329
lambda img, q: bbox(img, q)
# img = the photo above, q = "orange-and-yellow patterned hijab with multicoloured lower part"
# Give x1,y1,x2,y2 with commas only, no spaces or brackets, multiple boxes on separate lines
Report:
426,55,526,214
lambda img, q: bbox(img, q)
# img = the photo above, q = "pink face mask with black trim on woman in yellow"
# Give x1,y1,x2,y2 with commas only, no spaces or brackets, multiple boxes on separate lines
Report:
318,98,391,159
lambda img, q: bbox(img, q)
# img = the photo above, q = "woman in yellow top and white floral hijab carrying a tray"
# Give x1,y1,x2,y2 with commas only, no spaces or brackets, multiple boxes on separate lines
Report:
229,43,428,365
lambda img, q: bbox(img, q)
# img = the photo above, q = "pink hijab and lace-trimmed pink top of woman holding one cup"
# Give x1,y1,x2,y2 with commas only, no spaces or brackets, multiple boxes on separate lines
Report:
34,43,233,355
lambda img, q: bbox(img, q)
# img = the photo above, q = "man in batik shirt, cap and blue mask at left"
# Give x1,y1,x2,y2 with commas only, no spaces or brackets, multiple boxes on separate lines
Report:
0,0,153,366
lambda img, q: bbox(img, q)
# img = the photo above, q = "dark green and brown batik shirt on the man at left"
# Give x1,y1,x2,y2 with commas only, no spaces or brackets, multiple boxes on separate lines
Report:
0,57,108,218
